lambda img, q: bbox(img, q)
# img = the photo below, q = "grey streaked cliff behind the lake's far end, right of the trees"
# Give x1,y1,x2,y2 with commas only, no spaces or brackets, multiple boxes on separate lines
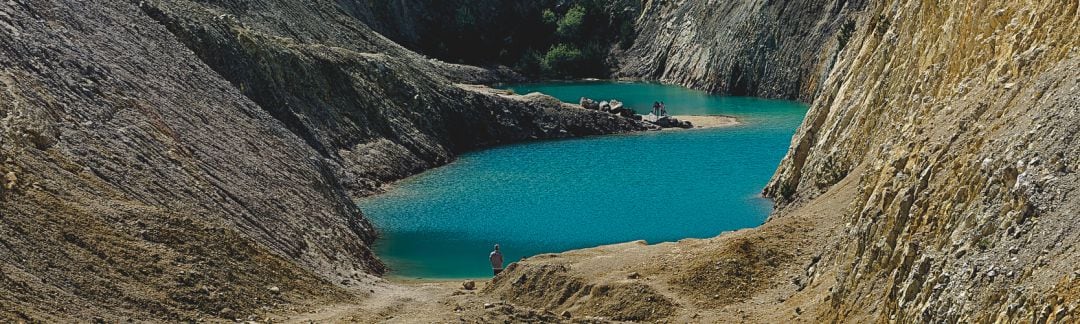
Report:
612,0,866,102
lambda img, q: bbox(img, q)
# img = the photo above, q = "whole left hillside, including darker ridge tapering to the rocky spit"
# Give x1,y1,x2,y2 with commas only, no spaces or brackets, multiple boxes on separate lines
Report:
0,1,644,322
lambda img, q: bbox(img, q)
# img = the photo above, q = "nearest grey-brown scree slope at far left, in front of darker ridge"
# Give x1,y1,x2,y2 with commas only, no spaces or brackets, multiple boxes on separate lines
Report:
0,1,362,322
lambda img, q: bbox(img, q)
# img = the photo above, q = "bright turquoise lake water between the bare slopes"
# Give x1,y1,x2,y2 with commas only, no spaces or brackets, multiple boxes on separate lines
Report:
360,82,806,279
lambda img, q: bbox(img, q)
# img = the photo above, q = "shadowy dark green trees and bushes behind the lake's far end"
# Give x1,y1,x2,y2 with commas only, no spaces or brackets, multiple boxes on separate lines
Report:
362,0,639,79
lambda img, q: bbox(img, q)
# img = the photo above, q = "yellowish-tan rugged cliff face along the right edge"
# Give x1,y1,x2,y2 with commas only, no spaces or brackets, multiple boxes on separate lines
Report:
766,1,1080,323
